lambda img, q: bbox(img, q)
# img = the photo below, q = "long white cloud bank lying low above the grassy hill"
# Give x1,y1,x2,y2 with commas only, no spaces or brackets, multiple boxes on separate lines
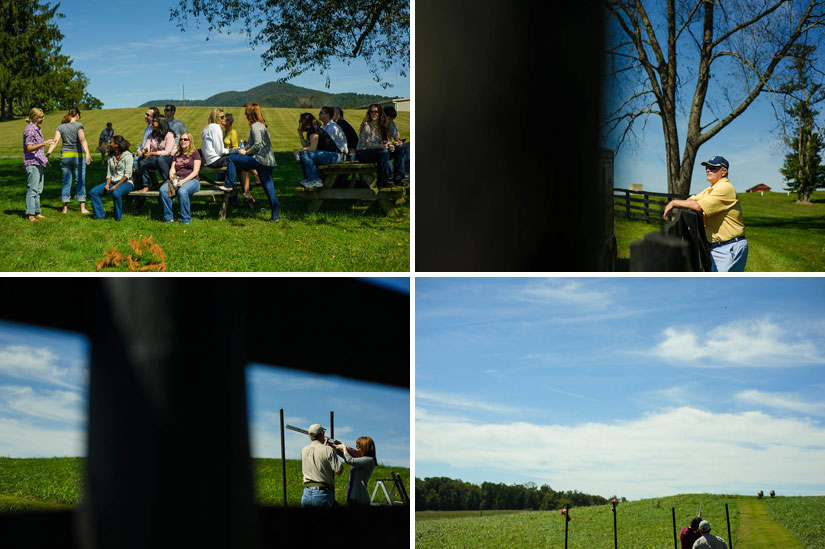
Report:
415,407,825,498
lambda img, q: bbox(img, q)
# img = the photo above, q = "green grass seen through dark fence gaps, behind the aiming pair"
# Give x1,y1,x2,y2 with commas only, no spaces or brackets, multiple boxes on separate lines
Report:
0,457,410,512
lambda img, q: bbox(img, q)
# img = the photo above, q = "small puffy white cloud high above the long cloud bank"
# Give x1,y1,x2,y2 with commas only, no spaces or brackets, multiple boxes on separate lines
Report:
651,319,825,368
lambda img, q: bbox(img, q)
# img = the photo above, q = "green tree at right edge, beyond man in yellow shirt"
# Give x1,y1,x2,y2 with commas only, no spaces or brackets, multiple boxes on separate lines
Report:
777,45,825,204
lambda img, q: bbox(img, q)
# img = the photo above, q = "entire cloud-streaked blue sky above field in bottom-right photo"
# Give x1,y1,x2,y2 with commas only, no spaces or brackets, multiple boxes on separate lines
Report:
415,277,825,499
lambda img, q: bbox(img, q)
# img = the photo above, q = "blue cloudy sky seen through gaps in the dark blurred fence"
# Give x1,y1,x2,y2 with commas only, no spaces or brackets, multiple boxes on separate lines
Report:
0,277,410,467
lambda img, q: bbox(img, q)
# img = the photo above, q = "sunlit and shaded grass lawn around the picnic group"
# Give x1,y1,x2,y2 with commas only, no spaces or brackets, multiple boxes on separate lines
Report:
0,107,411,272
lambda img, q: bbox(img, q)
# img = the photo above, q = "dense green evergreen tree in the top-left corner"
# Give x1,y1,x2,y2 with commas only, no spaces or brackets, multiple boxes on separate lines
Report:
0,0,103,118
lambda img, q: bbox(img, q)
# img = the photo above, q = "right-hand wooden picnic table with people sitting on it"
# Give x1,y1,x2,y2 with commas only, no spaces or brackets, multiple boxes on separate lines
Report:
295,161,407,217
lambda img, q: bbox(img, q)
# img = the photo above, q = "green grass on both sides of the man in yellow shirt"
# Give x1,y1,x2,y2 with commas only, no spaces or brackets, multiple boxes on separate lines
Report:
614,191,825,272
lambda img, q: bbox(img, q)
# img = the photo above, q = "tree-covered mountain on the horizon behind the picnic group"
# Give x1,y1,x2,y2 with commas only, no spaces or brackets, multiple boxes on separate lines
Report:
140,82,392,109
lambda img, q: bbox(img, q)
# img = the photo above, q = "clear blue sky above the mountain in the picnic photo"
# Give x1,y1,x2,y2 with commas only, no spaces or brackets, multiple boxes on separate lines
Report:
52,0,410,109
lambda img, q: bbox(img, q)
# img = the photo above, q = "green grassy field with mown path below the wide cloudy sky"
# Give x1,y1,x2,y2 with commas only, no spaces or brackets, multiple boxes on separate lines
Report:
415,494,825,549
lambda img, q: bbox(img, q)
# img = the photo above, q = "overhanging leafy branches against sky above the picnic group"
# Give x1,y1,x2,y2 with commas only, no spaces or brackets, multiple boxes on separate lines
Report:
170,0,410,88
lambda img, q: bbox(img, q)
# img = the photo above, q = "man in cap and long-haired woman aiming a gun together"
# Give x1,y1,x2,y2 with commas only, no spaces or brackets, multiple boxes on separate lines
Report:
301,423,378,507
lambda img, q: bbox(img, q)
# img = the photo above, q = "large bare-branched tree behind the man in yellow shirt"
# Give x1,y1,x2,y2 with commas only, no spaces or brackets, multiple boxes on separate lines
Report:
604,0,825,195
